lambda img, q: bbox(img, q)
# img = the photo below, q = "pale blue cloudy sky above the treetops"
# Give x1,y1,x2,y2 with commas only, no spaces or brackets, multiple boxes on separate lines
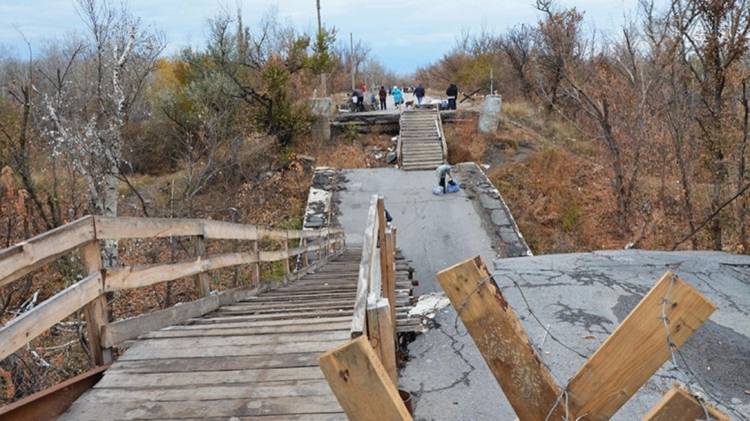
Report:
0,0,638,73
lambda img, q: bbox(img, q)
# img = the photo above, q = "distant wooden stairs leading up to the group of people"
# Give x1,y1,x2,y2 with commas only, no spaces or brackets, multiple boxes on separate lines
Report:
399,109,446,171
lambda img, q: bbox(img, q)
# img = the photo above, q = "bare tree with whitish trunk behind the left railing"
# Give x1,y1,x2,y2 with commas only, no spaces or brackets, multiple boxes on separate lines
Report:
42,0,164,265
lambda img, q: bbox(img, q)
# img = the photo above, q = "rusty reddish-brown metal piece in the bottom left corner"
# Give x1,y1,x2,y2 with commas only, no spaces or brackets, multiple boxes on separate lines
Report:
0,364,110,421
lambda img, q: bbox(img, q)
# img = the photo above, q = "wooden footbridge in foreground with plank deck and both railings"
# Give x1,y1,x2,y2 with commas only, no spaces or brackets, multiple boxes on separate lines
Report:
0,198,416,420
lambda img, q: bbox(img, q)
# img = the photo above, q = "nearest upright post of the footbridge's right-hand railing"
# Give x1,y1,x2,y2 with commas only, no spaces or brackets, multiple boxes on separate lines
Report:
367,298,398,386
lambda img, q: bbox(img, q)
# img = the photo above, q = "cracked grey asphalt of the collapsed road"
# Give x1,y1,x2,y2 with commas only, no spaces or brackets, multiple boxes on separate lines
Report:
336,169,750,420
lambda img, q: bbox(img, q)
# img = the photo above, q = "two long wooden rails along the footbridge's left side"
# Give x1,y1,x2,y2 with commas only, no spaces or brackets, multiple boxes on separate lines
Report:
0,216,345,360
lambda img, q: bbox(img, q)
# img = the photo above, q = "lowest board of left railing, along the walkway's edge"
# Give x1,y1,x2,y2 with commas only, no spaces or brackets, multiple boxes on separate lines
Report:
102,296,219,348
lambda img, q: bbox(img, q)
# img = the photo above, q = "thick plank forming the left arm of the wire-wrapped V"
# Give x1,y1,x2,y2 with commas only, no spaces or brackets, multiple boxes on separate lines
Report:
437,256,565,421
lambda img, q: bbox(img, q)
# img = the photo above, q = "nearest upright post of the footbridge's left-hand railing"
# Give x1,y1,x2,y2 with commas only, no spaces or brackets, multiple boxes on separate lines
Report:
81,241,112,365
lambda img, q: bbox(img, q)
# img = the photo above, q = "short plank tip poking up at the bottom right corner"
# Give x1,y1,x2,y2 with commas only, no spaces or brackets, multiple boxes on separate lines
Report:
643,384,731,421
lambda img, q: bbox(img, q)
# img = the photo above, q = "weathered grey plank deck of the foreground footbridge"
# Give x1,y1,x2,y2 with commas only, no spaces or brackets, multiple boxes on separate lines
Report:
60,249,415,421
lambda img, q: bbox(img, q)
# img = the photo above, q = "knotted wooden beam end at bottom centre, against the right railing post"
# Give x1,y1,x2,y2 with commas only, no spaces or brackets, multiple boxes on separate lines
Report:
320,337,412,421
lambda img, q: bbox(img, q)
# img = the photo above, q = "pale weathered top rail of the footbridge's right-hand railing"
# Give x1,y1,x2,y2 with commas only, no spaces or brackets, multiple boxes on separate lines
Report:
351,195,378,338
